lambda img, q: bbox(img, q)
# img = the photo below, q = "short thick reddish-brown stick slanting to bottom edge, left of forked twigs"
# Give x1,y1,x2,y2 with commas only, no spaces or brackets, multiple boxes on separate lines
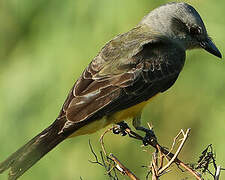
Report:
109,154,139,180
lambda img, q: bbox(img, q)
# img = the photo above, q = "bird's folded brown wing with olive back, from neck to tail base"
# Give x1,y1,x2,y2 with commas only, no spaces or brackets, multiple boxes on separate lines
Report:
61,26,185,122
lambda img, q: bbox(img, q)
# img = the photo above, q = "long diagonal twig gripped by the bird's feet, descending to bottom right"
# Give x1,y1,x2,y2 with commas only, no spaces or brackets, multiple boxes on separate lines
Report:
126,129,202,180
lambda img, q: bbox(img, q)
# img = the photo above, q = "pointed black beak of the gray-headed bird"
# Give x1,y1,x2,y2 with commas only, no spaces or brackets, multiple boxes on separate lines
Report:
200,38,222,58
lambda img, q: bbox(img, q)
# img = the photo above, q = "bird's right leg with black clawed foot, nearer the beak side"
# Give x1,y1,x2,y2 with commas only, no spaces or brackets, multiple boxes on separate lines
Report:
132,113,156,146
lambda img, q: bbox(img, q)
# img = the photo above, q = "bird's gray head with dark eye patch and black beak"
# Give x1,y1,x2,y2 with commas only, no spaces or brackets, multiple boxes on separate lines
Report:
140,2,222,58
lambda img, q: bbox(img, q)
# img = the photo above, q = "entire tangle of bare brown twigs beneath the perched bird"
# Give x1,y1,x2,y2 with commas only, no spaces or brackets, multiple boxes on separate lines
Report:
89,125,224,180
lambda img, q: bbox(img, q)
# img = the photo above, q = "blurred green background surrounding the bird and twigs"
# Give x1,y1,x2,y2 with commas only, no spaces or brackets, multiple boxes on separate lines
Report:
0,0,225,180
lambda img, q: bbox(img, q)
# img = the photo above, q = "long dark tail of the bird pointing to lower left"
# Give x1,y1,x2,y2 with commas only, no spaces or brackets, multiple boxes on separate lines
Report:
0,118,70,180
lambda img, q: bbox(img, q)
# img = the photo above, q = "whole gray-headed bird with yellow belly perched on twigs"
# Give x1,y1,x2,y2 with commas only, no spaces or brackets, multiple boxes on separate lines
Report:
0,2,222,180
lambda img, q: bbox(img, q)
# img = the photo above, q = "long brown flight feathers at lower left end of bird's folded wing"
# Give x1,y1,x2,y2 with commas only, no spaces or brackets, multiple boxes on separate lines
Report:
66,67,139,122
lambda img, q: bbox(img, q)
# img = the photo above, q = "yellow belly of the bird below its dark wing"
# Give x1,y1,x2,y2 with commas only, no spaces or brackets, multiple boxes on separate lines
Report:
70,95,156,137
